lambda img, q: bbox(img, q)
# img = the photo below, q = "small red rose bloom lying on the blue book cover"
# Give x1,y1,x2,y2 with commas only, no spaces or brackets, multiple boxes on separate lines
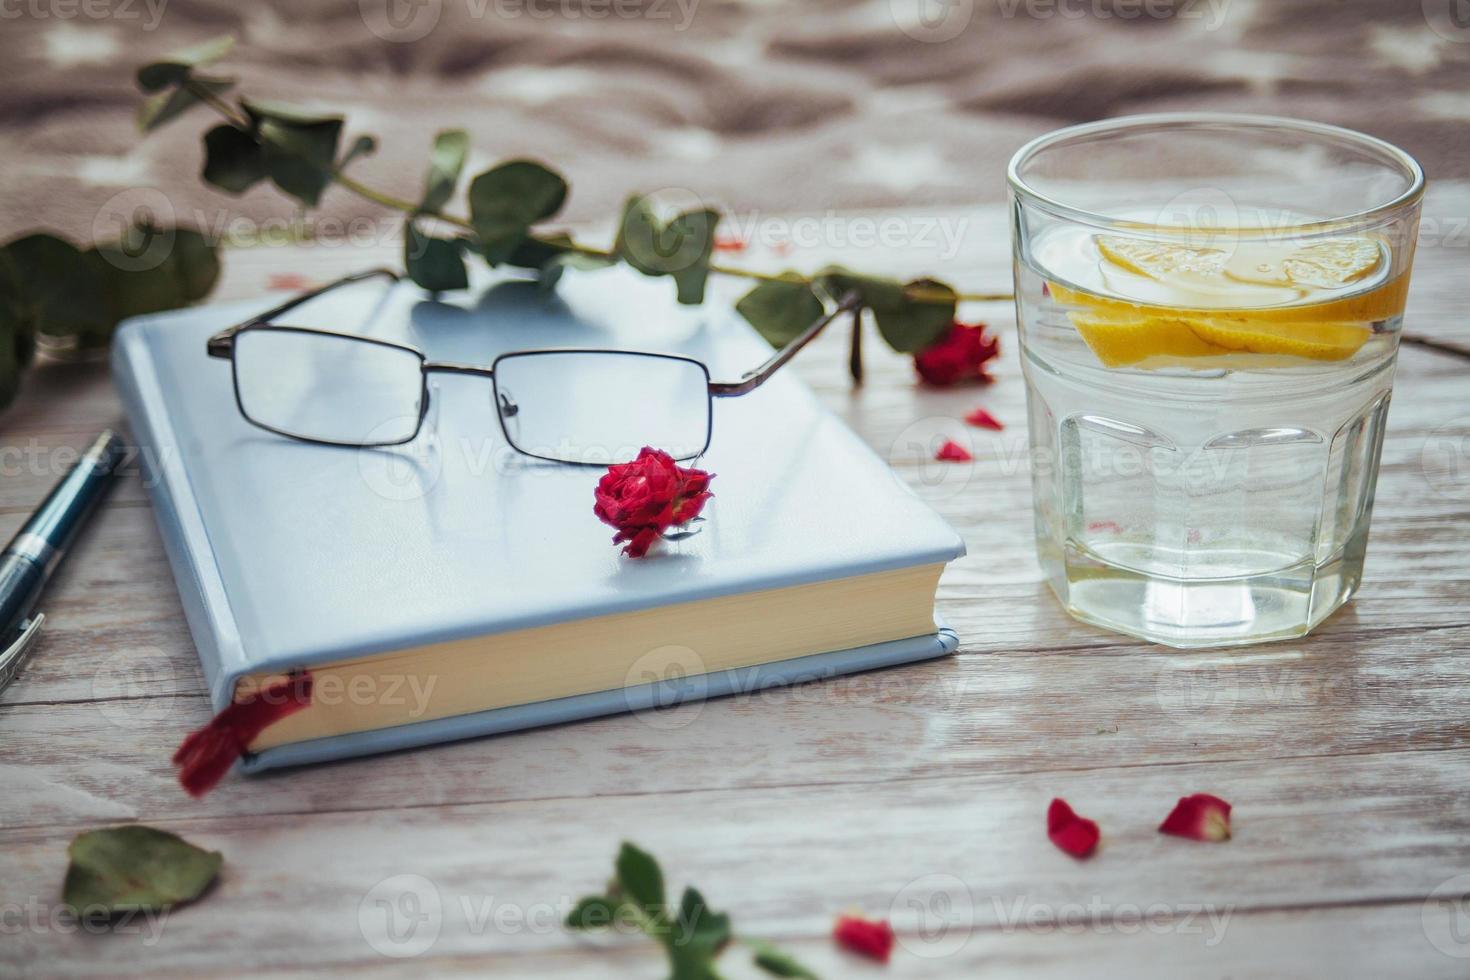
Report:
592,447,714,558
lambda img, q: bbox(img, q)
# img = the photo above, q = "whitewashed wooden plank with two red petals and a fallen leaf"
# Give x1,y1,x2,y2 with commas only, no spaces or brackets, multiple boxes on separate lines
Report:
0,749,1470,976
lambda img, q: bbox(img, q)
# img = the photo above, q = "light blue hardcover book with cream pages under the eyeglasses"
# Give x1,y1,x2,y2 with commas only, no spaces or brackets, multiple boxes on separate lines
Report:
113,269,964,771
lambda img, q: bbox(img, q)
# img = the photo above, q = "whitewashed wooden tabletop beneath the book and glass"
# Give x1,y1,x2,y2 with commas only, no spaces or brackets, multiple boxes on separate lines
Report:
0,195,1470,979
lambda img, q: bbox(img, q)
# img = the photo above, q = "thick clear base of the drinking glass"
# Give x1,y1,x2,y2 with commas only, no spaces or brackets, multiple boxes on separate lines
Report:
1038,531,1367,649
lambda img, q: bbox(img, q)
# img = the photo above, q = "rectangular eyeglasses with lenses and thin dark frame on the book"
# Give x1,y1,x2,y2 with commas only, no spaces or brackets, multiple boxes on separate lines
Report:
207,269,858,466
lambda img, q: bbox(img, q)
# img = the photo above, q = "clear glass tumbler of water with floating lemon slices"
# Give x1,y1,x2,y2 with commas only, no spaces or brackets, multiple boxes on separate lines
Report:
1008,113,1424,646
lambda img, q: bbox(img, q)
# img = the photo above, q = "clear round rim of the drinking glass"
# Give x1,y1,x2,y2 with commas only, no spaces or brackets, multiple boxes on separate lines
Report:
1005,112,1424,237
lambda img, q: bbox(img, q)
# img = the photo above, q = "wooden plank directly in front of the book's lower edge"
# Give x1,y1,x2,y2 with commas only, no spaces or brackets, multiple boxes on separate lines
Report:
0,617,1470,827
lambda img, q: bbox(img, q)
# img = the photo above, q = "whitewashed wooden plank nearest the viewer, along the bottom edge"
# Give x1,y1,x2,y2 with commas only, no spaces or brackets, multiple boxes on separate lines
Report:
255,902,1466,980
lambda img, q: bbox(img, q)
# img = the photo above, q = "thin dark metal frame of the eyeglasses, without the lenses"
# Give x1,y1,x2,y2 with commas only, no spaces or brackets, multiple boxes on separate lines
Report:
204,267,860,466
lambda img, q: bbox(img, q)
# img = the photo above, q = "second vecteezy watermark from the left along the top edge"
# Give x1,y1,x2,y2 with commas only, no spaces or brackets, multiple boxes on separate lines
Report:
357,0,700,44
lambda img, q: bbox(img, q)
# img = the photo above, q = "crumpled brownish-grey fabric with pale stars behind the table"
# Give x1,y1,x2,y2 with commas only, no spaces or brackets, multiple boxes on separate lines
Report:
0,0,1470,245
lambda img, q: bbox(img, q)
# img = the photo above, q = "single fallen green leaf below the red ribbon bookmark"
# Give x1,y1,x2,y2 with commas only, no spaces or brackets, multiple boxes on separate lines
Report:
63,824,223,915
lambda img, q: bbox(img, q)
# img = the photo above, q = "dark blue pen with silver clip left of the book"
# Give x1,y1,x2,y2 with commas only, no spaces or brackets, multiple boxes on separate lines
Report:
0,429,123,691
